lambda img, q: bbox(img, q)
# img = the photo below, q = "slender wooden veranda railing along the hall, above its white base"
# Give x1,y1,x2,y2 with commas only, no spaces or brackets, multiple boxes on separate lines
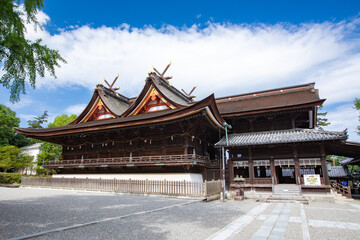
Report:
43,154,211,168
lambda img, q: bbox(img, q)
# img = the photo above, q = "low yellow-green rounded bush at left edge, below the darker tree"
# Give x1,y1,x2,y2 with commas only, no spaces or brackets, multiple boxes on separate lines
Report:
0,145,33,172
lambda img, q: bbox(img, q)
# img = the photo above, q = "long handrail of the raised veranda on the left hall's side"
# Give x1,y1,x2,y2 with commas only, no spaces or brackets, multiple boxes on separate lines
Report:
44,154,211,166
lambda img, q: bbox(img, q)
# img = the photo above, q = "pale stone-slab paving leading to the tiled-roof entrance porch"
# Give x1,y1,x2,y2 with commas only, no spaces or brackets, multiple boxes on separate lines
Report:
208,200,360,240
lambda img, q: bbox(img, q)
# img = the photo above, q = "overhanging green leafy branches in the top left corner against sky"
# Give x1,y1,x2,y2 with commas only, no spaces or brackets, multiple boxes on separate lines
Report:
0,0,66,102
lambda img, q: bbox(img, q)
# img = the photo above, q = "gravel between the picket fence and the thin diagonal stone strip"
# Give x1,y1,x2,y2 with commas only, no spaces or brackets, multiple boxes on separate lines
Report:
0,188,193,239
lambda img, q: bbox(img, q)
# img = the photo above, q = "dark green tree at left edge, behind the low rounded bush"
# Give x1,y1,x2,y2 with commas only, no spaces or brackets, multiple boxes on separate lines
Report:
0,104,30,147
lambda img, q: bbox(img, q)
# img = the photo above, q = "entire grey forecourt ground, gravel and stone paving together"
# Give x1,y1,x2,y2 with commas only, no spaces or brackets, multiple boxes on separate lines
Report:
0,188,360,240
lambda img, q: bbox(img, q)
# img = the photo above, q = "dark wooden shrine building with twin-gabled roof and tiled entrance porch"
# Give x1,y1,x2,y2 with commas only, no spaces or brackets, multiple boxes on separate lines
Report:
16,65,360,195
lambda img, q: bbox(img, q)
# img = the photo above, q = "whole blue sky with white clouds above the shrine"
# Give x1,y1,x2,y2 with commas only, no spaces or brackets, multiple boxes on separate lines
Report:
0,0,360,141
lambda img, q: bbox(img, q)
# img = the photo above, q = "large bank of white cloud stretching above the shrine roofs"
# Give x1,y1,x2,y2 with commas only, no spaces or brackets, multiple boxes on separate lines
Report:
21,10,360,141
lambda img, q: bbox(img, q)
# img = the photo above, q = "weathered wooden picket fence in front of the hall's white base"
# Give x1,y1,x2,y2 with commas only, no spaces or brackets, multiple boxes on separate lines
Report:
21,177,221,197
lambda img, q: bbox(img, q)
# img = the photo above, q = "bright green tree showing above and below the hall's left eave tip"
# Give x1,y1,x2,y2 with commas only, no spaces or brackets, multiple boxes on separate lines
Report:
37,114,76,164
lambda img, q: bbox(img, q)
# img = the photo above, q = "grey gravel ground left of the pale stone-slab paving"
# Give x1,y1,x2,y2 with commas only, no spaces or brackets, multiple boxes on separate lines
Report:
0,188,257,239
